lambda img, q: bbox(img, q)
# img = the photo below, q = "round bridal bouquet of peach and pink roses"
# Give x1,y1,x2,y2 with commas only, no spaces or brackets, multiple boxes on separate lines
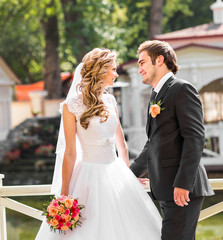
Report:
43,196,84,233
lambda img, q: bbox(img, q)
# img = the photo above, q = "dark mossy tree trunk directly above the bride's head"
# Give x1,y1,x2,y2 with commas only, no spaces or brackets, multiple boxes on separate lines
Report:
61,0,88,62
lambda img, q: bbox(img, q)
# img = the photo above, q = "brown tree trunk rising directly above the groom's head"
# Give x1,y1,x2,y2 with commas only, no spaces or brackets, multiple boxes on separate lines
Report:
149,0,164,39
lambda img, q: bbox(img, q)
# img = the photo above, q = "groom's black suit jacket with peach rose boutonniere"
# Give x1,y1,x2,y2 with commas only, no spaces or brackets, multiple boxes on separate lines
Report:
130,76,214,201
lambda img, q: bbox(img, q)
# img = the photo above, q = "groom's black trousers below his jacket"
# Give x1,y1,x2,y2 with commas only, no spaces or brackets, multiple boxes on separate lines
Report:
159,197,204,240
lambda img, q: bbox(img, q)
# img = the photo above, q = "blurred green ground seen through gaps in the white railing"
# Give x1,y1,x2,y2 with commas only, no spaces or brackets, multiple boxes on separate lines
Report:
6,191,223,240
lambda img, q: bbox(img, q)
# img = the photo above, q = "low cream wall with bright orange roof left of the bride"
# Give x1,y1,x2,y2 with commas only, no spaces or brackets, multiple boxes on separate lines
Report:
11,72,73,127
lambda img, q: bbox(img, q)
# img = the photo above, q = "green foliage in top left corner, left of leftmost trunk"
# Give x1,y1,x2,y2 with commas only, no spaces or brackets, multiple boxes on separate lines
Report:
0,0,44,82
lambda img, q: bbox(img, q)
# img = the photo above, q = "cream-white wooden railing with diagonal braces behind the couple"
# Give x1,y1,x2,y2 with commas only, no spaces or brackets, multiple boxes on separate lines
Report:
0,174,223,240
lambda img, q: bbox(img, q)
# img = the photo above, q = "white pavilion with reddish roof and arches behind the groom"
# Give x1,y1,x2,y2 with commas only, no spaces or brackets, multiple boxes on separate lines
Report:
116,0,223,164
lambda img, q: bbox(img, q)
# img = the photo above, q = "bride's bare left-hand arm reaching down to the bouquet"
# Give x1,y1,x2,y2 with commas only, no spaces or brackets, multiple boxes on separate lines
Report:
61,104,76,196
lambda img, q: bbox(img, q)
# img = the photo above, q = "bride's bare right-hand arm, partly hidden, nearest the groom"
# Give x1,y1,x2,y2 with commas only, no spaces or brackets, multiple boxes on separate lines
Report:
115,109,129,167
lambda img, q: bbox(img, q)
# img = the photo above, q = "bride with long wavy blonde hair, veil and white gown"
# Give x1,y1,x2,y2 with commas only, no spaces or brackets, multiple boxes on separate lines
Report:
36,48,161,240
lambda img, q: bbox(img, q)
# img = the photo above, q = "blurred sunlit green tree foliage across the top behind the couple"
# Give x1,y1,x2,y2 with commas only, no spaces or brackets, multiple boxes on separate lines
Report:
0,0,217,83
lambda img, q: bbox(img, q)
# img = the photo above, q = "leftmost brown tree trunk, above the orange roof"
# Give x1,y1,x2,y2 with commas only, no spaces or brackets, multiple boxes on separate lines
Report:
42,0,61,99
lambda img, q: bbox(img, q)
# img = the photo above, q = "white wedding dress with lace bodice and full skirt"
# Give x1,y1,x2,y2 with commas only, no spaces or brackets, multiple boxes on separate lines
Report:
36,94,162,240
